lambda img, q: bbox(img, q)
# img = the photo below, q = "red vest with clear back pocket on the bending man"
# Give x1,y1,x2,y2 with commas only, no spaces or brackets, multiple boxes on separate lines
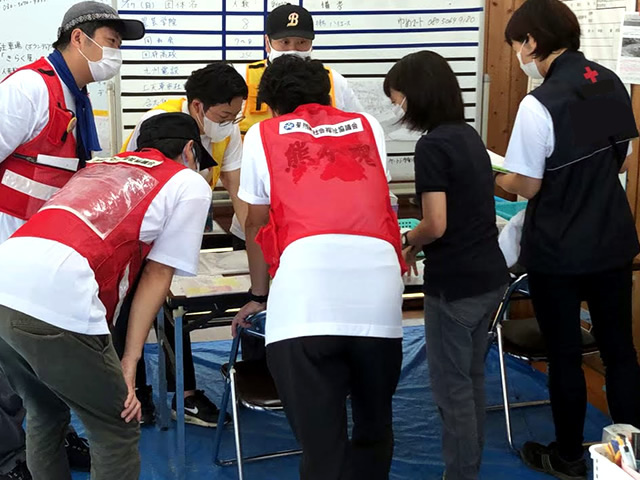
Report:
12,150,186,325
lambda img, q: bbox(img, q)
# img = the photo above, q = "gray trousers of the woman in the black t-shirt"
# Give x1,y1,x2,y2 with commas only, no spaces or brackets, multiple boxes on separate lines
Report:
424,285,506,480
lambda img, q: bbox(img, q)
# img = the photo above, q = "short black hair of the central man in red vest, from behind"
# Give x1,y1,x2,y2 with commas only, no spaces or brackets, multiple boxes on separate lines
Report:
258,55,331,115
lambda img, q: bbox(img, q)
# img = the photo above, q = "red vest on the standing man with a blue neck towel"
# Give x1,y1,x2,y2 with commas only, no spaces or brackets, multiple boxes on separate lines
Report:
0,58,78,220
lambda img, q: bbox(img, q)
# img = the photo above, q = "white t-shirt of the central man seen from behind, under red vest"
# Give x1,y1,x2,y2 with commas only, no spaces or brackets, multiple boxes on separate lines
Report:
238,114,404,344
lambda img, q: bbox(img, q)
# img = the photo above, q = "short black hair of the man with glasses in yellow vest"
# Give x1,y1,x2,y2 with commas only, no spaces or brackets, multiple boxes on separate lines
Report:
184,61,249,111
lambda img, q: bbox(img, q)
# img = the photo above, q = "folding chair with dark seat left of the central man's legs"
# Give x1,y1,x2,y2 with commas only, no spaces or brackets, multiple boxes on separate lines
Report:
214,312,302,480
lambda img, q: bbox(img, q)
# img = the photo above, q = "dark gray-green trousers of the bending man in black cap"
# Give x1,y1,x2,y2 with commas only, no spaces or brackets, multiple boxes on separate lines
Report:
0,306,140,480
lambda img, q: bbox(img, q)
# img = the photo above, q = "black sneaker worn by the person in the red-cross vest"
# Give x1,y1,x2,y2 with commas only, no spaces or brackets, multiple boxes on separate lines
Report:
520,442,587,480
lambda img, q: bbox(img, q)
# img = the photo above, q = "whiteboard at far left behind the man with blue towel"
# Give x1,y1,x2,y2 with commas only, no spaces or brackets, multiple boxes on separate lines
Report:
0,0,113,153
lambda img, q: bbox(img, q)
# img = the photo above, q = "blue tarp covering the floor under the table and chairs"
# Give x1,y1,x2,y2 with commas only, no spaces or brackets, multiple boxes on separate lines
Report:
74,327,609,480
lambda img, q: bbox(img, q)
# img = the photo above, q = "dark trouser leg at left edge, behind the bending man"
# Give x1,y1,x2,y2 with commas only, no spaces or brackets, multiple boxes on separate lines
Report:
0,365,25,475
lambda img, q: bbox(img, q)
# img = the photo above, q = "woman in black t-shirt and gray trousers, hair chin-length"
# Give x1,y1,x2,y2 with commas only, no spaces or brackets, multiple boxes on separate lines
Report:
384,51,508,480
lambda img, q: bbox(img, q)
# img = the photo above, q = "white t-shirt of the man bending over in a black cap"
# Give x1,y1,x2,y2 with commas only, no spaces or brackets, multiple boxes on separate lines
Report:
0,169,211,335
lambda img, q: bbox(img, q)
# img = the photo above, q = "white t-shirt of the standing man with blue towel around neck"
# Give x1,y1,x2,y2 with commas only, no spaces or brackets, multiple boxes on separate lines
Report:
0,62,76,243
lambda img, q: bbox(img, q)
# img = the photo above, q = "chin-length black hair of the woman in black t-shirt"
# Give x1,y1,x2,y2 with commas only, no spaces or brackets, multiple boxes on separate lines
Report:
383,50,464,132
